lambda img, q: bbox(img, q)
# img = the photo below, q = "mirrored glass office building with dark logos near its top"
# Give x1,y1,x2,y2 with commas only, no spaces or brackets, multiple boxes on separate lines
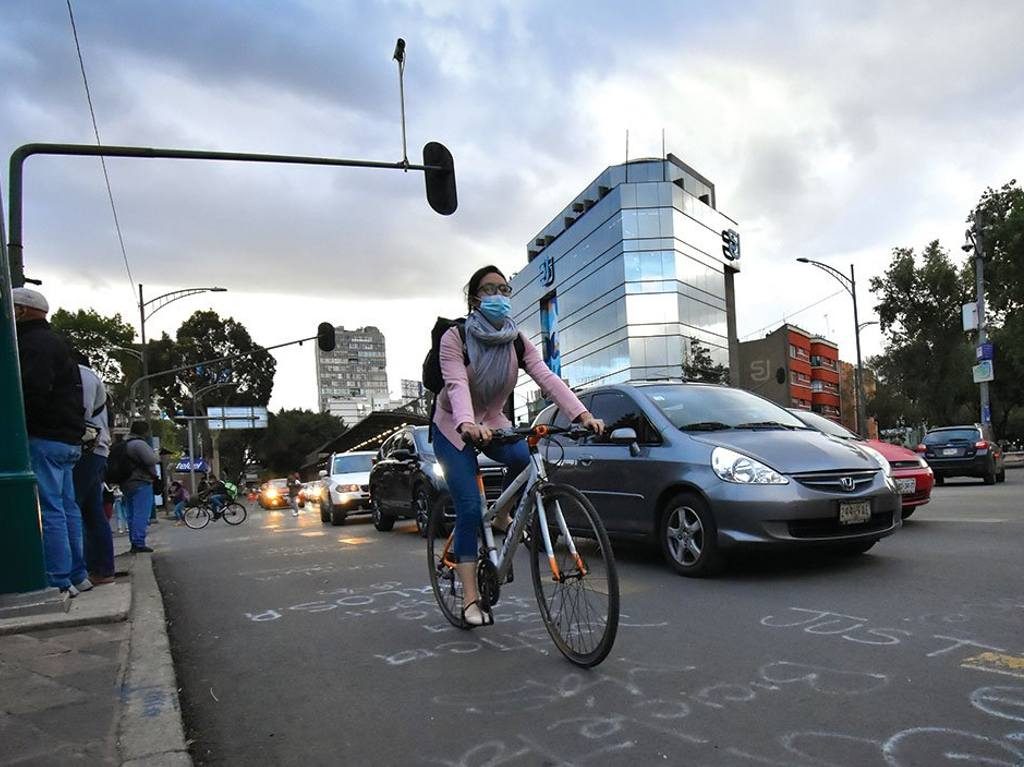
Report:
511,155,740,418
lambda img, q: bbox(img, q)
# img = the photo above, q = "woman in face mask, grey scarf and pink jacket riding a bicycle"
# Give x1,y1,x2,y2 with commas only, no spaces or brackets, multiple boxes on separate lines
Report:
432,266,604,626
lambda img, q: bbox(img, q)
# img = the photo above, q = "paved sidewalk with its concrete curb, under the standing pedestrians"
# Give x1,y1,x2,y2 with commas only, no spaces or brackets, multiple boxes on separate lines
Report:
0,519,191,767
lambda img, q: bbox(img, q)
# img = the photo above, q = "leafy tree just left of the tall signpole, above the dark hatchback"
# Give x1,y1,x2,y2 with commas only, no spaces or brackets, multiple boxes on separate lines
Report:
871,241,976,427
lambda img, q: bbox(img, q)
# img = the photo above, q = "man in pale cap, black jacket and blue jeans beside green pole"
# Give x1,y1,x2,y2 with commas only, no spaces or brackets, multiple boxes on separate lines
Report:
11,288,92,597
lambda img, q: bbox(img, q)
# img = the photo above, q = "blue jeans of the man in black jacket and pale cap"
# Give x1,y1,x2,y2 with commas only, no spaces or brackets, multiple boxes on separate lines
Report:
29,437,86,589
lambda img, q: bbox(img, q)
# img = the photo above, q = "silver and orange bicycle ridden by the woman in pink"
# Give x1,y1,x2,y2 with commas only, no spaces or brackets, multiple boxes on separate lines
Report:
427,426,618,668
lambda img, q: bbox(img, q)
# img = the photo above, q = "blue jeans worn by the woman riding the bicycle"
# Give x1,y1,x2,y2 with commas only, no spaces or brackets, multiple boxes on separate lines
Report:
431,426,529,562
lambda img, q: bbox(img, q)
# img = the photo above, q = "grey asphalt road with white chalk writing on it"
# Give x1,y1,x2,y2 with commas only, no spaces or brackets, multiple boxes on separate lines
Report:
156,471,1024,767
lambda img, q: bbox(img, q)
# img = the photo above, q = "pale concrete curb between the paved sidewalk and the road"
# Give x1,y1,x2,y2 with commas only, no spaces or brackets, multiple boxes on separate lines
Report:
118,554,193,767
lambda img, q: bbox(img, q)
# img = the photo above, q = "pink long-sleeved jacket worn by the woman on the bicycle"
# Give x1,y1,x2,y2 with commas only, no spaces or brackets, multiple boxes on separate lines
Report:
434,328,587,450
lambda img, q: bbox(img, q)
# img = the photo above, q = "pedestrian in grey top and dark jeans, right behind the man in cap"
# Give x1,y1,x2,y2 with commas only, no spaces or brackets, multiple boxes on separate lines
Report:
74,354,114,585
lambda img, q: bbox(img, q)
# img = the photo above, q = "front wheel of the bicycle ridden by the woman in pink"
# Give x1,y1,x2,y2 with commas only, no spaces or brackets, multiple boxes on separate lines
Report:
530,484,618,668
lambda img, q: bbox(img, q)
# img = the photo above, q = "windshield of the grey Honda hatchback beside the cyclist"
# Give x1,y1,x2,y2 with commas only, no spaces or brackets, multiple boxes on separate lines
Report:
641,384,807,431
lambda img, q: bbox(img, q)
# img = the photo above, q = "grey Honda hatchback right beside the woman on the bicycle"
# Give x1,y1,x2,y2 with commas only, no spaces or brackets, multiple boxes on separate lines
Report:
535,382,902,576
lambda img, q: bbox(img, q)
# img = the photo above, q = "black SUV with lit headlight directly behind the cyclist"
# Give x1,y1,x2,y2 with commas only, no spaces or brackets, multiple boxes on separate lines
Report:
370,426,505,536
